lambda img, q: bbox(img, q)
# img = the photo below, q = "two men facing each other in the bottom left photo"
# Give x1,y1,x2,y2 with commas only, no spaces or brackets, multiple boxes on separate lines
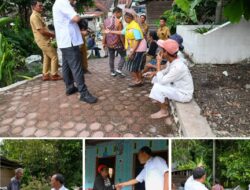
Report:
7,168,68,190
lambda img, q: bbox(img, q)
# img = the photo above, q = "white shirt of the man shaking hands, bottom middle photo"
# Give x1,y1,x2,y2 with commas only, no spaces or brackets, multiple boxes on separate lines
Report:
136,156,168,190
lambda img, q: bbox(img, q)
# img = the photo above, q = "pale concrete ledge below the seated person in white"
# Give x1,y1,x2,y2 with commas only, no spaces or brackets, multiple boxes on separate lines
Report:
173,100,215,137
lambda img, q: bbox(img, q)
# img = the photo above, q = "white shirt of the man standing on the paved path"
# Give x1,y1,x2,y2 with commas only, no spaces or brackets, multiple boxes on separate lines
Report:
53,0,83,48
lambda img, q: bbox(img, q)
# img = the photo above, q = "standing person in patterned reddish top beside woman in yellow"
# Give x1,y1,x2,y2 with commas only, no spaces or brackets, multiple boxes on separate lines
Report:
103,7,126,77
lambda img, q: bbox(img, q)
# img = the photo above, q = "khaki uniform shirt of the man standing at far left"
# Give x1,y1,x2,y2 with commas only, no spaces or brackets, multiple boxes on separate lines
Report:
30,10,50,46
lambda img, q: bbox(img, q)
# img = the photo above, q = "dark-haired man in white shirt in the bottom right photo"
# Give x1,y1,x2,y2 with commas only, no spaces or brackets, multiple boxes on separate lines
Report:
184,167,208,190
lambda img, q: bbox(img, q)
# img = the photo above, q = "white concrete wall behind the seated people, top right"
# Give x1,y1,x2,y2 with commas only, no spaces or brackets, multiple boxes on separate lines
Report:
177,20,250,64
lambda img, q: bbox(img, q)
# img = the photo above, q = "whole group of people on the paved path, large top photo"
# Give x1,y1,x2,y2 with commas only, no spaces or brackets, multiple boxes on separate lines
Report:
30,0,194,119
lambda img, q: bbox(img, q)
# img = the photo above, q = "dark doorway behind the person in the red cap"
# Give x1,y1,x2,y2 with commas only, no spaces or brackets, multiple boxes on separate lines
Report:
96,156,116,183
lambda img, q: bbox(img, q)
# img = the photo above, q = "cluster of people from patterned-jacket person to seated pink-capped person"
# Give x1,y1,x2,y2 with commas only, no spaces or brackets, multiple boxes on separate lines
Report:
103,7,194,119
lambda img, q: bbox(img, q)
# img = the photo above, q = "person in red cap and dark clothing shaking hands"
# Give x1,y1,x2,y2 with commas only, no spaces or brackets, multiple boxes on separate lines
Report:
93,164,119,190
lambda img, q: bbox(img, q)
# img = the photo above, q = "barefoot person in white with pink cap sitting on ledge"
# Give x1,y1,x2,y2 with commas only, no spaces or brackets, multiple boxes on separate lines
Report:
148,39,194,119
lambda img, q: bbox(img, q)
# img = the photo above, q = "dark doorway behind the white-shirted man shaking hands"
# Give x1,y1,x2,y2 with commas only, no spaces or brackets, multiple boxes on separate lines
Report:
133,150,168,190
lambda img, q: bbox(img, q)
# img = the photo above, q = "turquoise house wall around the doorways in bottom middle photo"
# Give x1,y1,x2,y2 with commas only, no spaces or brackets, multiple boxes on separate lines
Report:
85,140,168,190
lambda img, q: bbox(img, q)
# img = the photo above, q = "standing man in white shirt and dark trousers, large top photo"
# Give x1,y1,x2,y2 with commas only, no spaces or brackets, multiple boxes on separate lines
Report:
53,0,97,103
